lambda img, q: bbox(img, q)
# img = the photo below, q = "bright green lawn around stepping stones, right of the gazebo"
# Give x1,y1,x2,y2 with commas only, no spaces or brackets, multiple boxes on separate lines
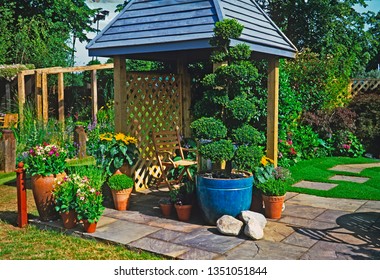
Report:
288,157,380,200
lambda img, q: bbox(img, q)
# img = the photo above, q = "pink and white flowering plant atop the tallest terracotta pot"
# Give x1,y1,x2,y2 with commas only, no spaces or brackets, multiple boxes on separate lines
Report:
23,143,67,176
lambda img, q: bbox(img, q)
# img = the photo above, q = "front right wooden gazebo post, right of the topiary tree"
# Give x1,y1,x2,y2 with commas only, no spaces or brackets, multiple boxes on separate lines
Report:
267,57,280,166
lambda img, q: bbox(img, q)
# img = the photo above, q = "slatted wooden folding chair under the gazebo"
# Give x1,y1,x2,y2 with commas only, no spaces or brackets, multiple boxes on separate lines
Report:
152,126,197,189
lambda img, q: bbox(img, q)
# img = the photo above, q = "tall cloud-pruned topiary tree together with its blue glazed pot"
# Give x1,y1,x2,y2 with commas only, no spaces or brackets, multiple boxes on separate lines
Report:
191,19,263,225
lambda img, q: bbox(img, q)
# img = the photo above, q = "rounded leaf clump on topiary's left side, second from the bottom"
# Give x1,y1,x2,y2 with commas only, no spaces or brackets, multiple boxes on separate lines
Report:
190,117,227,140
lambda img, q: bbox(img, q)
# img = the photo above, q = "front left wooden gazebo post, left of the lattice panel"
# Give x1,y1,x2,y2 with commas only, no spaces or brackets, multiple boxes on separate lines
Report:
114,56,128,133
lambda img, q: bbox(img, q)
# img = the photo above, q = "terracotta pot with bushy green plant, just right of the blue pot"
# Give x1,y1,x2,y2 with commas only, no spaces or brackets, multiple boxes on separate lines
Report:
257,164,290,219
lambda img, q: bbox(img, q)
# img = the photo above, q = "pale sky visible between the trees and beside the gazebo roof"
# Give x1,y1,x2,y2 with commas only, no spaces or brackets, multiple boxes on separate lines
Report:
75,0,380,66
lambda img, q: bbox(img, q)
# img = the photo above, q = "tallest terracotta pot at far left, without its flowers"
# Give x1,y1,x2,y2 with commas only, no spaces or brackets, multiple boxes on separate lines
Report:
31,173,66,221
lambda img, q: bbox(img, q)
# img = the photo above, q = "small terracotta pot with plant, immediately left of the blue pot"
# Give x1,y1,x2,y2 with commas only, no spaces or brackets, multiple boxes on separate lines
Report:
170,181,195,222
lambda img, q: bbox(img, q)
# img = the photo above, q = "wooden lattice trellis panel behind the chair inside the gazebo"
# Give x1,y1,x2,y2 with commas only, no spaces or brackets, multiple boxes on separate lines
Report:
126,73,182,191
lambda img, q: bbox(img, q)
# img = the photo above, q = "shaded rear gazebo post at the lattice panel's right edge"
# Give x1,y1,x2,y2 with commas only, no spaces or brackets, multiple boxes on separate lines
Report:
177,58,191,137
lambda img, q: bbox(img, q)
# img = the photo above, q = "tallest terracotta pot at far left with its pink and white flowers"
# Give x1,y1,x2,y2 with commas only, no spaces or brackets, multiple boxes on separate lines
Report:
21,143,67,221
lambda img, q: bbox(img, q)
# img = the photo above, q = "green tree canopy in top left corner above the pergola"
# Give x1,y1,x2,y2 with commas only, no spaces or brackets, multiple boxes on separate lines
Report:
0,0,94,67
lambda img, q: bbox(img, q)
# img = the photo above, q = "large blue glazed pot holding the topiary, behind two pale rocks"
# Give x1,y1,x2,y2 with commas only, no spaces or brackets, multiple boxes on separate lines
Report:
196,175,253,225
